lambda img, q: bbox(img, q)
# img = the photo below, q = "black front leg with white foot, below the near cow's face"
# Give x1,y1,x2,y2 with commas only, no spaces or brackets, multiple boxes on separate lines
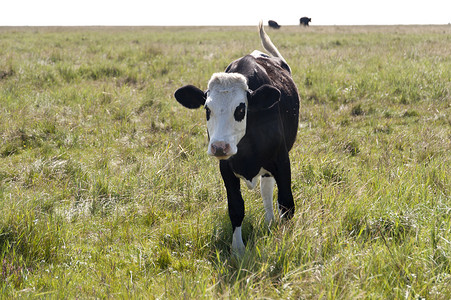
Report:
219,160,245,256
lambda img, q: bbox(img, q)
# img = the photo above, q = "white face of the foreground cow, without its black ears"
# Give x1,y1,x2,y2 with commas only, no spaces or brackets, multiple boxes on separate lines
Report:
205,73,248,159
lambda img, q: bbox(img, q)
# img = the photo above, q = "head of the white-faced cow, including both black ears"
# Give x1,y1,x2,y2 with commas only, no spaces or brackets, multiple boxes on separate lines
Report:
174,73,280,159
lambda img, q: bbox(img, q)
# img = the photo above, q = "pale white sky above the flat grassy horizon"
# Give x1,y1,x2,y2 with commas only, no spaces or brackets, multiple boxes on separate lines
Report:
0,0,451,26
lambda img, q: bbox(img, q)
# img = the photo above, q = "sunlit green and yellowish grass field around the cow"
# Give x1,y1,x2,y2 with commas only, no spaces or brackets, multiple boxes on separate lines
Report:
0,26,451,299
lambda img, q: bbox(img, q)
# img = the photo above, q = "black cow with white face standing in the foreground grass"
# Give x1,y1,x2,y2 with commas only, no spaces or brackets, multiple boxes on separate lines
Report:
174,22,299,255
